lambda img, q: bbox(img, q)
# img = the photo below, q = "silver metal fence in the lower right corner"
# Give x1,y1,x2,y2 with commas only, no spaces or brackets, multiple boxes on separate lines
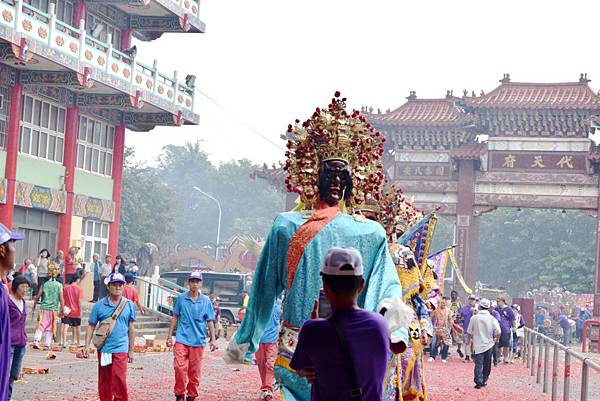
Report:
523,327,600,401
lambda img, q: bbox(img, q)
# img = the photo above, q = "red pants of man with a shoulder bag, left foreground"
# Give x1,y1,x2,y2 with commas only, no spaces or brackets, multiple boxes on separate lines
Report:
98,352,128,401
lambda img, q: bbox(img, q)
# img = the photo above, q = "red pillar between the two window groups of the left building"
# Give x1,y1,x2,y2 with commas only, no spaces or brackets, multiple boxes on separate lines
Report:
58,106,79,254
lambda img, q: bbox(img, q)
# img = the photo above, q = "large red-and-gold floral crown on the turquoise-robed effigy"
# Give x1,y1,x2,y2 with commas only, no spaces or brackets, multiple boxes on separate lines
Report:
283,92,385,210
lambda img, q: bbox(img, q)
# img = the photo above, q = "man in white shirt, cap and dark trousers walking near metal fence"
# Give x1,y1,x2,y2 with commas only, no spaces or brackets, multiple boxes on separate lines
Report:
467,298,500,389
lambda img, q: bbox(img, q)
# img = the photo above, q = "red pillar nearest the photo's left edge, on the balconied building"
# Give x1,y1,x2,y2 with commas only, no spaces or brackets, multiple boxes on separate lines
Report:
0,83,23,229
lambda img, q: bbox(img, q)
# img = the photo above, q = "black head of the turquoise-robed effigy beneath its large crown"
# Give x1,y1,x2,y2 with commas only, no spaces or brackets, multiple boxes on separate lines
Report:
318,160,352,206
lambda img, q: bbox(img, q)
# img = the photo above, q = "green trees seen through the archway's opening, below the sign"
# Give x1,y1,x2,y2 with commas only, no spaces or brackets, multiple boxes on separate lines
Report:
478,208,596,295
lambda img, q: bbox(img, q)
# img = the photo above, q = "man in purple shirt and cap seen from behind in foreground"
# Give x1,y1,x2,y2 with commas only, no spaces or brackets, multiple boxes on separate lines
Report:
290,248,390,401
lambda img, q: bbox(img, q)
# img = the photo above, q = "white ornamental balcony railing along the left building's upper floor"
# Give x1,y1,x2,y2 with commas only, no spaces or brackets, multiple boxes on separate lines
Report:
0,0,194,111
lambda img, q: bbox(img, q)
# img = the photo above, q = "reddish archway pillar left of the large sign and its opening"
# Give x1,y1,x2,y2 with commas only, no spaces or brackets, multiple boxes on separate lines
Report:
456,160,479,287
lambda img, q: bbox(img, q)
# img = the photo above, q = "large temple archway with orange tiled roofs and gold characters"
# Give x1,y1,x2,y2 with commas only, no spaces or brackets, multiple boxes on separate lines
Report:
363,74,600,316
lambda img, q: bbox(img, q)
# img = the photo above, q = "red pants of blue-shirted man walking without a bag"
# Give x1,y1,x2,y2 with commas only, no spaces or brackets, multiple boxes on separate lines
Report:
173,343,204,397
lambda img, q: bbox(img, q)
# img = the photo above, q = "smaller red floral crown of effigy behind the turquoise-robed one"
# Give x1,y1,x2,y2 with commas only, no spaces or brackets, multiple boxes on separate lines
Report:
377,185,425,238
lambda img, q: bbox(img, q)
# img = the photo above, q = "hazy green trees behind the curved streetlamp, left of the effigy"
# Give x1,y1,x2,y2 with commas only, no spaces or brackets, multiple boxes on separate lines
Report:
158,142,284,253
